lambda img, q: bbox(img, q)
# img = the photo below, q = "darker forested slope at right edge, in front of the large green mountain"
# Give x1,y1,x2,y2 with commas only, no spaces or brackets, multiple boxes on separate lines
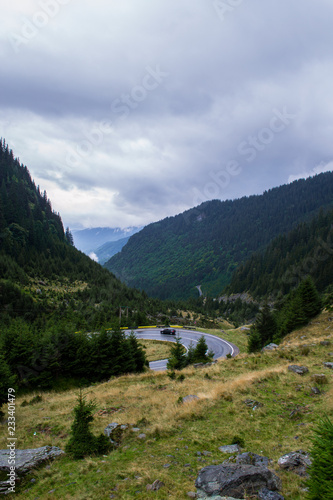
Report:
227,206,333,298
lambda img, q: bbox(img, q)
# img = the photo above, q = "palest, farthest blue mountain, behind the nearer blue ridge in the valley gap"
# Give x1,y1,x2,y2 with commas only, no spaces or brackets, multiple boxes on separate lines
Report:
73,227,141,255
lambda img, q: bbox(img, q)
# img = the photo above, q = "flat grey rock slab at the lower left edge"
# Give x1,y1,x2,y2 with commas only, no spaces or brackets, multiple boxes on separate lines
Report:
0,446,64,493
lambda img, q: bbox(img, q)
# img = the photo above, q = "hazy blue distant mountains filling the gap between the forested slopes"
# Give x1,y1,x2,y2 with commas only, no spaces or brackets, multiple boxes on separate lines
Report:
73,227,141,264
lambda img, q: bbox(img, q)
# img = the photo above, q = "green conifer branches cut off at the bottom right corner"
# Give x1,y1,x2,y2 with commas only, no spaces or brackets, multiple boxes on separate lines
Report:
307,416,333,500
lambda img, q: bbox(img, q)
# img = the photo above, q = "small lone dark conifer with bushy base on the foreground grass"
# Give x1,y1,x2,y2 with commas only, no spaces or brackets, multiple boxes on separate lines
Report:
65,392,111,459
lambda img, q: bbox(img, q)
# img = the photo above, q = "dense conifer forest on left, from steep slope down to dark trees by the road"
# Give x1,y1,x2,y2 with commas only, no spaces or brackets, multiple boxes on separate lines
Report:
0,140,158,396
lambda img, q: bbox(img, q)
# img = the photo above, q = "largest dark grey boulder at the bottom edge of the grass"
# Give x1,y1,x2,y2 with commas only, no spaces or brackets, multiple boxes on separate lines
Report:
195,464,282,499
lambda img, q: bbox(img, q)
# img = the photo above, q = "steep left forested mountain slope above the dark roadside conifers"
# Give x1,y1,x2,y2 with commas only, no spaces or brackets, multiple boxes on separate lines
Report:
0,140,156,331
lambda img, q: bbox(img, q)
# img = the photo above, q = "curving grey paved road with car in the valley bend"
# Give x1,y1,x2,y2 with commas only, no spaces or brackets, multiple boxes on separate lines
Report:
125,328,239,371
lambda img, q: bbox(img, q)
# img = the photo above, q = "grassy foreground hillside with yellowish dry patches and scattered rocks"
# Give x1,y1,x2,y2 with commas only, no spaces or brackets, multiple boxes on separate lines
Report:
0,312,333,500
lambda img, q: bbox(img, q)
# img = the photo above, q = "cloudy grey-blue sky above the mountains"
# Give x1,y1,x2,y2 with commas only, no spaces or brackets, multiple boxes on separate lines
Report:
0,0,333,229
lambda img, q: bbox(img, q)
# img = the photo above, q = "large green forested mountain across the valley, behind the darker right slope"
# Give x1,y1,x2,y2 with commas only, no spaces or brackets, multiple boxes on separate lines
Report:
105,172,333,299
